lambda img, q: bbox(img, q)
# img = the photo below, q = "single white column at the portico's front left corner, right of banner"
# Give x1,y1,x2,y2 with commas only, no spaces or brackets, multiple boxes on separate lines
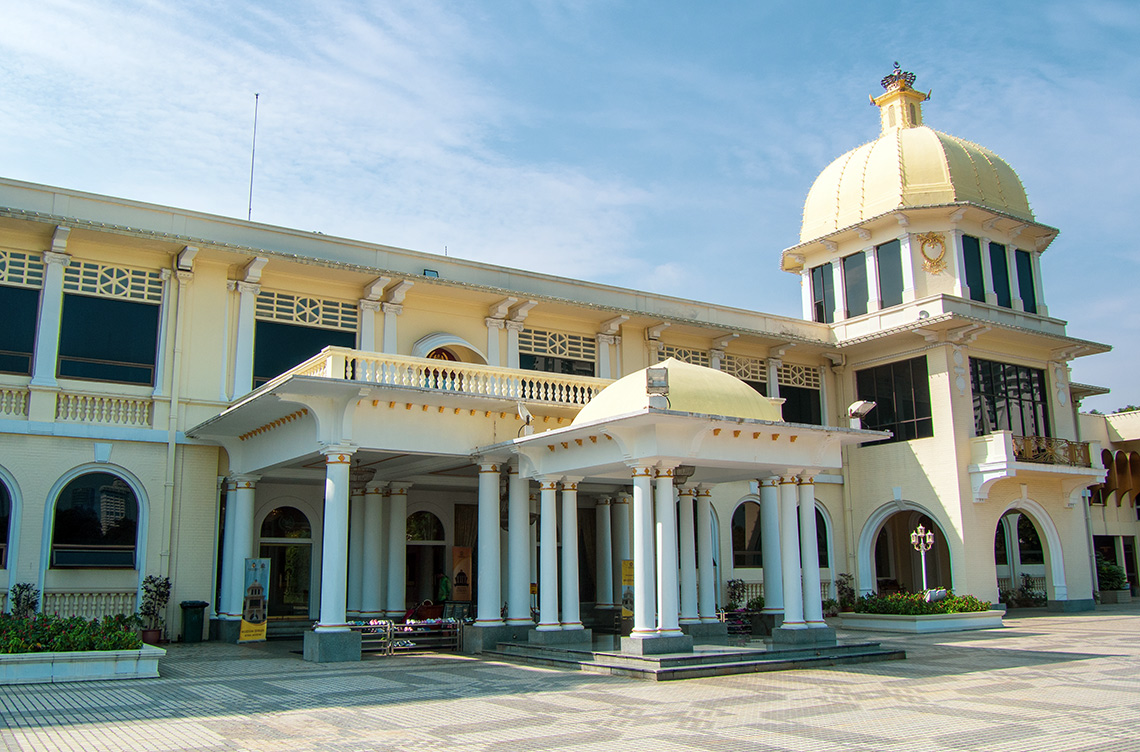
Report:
314,447,352,632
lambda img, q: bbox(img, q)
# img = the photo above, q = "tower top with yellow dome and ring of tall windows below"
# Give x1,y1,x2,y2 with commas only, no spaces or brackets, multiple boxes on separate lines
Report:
781,63,1057,330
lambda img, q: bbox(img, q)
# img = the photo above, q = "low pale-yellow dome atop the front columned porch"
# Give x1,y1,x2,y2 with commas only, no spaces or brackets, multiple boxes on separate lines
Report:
571,358,783,425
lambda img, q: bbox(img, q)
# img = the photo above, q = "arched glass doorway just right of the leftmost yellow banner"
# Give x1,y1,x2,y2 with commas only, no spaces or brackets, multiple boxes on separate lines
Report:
260,507,312,619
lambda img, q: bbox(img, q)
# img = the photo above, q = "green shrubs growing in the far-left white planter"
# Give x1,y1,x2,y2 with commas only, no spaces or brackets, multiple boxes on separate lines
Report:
0,614,143,653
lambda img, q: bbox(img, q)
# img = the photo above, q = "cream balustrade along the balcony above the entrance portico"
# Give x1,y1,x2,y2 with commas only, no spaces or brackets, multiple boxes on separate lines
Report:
285,348,612,407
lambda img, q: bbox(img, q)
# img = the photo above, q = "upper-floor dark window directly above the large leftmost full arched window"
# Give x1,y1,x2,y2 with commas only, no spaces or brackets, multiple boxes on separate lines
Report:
59,295,158,385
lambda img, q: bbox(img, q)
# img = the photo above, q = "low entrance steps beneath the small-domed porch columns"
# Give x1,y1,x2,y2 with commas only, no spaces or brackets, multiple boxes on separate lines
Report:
482,643,906,681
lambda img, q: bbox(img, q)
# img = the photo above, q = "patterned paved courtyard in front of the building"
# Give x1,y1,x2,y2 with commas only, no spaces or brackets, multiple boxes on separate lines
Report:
0,605,1140,752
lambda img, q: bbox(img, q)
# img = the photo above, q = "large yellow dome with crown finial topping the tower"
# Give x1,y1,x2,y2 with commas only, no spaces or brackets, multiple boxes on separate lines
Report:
799,64,1033,243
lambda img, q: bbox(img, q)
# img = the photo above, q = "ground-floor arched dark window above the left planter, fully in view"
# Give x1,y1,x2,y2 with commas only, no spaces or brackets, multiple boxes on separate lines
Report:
51,473,139,569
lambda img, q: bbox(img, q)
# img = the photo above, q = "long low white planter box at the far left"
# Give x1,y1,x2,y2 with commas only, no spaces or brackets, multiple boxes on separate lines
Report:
0,645,166,685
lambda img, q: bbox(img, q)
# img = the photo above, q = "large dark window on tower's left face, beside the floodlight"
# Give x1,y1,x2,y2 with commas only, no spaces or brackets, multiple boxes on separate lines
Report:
855,357,934,446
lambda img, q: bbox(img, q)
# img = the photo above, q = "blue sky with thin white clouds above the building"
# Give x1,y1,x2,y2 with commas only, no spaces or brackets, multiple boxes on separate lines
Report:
0,0,1140,410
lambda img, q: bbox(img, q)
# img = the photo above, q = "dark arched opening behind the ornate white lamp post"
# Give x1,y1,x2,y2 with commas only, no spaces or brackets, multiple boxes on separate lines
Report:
870,509,953,592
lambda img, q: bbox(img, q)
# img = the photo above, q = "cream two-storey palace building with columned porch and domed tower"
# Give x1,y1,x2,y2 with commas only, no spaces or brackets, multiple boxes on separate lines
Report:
0,71,1121,654
